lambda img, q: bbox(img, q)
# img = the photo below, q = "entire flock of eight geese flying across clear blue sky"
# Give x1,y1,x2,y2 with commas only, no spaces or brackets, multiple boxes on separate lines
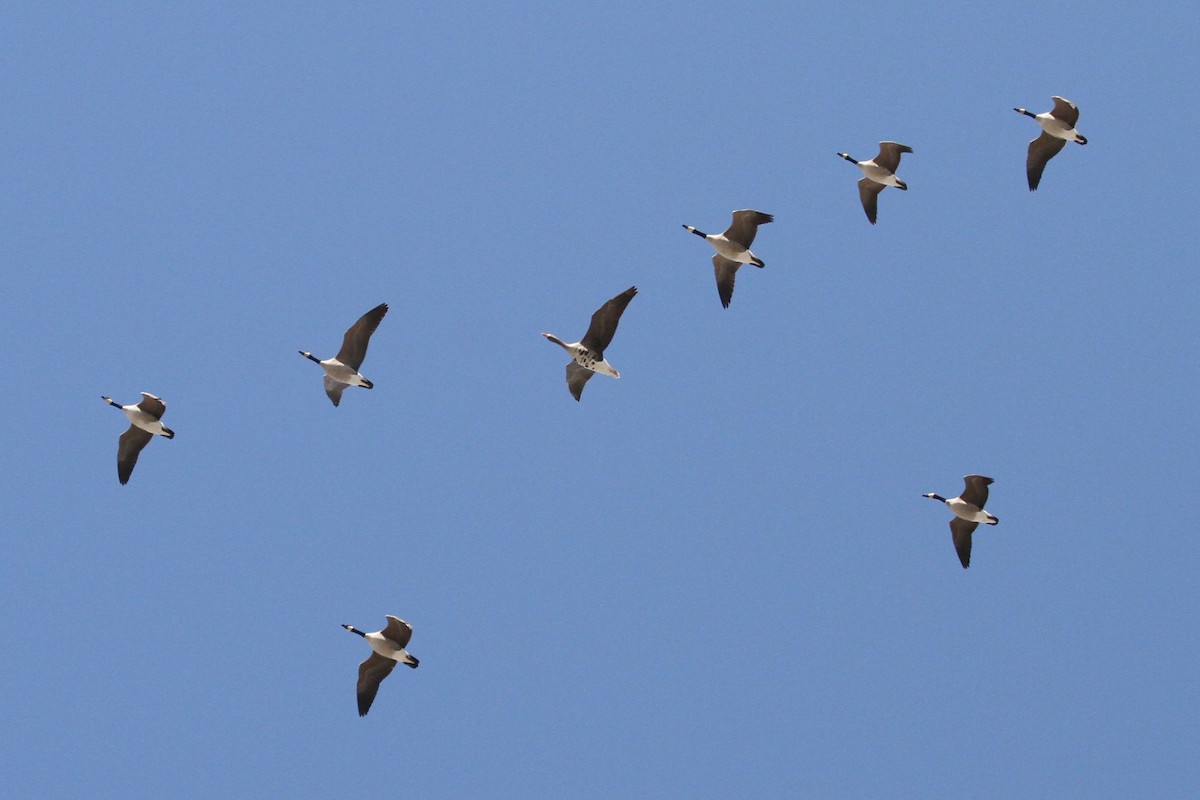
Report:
103,96,1087,716
